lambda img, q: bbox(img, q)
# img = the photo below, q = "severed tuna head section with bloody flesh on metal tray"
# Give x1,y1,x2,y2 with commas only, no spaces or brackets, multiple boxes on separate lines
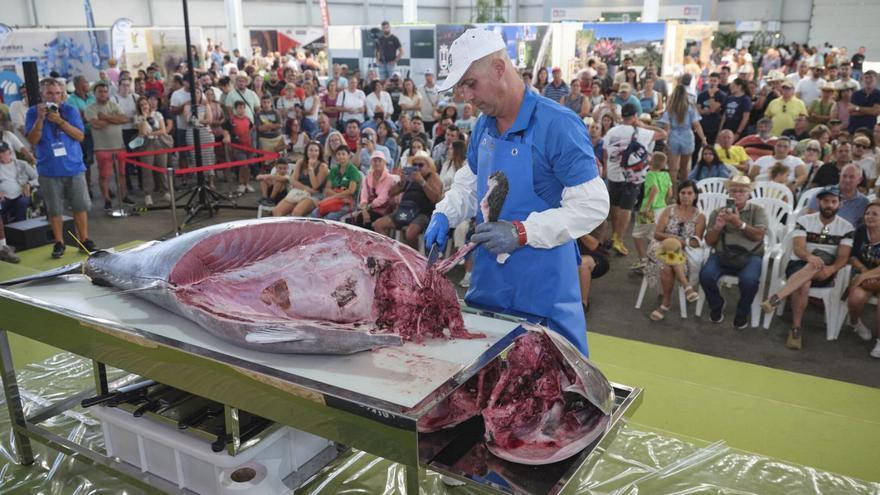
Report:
482,331,610,464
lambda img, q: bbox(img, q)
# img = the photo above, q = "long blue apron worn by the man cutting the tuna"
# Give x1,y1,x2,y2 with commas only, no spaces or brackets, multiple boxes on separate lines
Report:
465,122,589,356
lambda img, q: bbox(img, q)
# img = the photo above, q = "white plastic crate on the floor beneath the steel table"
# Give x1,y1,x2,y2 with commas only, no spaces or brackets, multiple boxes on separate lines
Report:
88,406,330,494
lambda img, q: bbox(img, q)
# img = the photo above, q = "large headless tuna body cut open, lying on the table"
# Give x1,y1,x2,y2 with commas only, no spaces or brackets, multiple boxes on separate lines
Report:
3,218,481,354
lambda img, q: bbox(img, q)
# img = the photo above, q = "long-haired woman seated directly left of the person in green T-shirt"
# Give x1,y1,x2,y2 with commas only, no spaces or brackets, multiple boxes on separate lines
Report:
272,140,328,217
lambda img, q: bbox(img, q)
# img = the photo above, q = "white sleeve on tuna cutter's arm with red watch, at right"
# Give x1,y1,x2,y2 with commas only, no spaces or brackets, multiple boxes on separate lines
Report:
520,176,610,249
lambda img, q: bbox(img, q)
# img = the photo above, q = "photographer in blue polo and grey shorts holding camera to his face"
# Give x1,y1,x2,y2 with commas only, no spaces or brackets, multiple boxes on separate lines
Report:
24,78,96,258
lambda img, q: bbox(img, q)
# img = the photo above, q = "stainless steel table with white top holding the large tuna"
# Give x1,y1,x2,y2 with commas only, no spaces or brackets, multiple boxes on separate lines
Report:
0,275,640,493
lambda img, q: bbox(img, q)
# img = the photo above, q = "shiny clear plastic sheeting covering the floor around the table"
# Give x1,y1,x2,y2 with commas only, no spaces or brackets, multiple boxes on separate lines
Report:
0,353,880,495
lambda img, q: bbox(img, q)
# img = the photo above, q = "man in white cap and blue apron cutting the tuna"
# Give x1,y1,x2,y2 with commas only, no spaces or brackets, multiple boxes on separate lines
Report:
425,29,608,355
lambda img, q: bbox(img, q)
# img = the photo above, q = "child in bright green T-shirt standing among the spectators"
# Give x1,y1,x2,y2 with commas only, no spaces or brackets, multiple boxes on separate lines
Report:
630,152,672,272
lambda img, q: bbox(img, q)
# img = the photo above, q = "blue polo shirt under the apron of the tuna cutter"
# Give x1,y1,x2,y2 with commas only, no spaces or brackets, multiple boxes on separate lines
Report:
468,87,599,208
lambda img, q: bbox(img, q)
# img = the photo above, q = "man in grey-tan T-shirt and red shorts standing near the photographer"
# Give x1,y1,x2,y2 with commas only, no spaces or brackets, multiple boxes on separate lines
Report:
85,81,134,210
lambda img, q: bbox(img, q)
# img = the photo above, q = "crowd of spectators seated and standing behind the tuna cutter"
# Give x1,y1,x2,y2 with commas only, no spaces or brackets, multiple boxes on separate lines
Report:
0,31,880,357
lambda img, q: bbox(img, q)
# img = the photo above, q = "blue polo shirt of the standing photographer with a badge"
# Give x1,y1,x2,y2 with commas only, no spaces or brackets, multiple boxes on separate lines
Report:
24,103,86,177
